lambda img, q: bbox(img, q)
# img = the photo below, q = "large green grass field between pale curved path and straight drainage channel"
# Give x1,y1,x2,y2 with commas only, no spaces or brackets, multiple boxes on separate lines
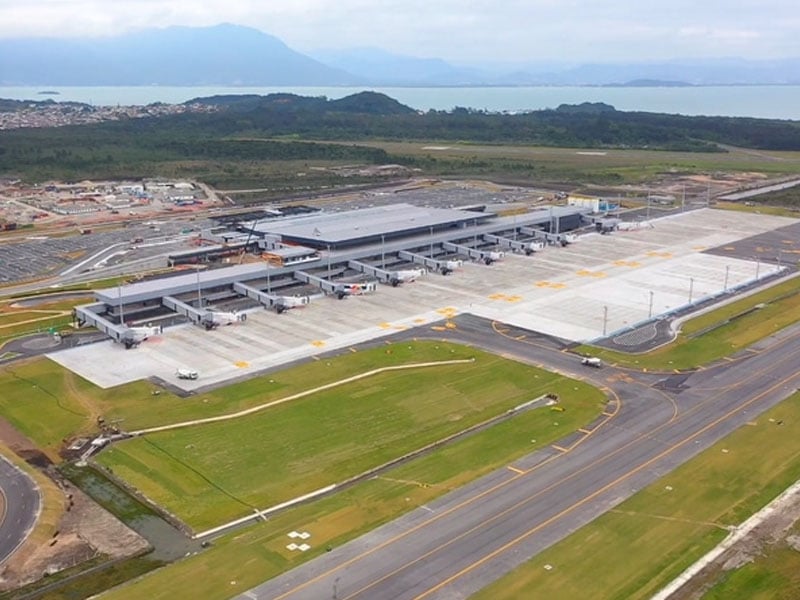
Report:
97,350,592,530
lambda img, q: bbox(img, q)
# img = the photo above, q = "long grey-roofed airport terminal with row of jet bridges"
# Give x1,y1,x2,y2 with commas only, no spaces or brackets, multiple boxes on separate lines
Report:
75,204,594,347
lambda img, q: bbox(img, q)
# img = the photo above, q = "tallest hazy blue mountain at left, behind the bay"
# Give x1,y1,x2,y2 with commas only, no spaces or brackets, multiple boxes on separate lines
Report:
0,24,363,86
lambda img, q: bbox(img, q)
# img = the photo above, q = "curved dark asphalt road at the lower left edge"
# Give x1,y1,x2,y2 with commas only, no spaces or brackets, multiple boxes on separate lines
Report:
0,456,40,564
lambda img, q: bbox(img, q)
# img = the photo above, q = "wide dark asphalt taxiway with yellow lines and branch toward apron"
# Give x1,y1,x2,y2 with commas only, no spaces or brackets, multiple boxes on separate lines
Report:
239,317,800,600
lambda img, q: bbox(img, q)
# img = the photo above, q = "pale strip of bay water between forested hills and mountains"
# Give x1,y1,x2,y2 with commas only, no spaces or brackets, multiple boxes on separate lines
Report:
0,85,800,120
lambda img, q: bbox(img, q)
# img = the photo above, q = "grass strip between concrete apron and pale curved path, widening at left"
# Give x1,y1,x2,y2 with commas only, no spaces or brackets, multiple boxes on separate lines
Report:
0,342,476,455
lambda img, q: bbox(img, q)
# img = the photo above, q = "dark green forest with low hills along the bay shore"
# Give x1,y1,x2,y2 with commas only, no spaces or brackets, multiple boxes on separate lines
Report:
0,92,800,189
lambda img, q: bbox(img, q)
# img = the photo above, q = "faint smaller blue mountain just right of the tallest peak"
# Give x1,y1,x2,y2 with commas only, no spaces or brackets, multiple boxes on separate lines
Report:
312,48,484,86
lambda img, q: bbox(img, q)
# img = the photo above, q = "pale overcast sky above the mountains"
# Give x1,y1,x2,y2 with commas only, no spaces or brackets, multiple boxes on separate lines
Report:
0,0,800,63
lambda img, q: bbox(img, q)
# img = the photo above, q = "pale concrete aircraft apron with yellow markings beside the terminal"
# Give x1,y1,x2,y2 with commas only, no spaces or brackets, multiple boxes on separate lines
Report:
45,210,791,390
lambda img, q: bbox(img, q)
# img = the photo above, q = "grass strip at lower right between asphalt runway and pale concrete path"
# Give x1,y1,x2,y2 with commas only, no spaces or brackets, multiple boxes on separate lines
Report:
475,394,800,600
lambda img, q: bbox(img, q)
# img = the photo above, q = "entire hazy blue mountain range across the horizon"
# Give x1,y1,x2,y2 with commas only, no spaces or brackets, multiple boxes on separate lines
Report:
0,24,800,87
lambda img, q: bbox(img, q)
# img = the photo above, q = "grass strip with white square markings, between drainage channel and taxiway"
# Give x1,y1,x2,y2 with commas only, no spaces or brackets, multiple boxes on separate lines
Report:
97,379,604,600
